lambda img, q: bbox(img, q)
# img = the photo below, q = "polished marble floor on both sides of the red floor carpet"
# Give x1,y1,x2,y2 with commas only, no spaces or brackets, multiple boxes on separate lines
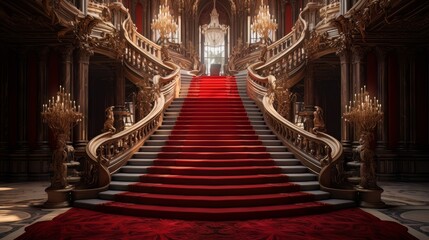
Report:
0,182,429,240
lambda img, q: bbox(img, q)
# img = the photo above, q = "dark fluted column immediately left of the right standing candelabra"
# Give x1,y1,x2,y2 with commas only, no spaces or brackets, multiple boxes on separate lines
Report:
339,51,352,151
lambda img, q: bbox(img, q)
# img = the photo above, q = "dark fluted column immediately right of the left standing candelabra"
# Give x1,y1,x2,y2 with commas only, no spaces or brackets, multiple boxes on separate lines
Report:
73,49,91,151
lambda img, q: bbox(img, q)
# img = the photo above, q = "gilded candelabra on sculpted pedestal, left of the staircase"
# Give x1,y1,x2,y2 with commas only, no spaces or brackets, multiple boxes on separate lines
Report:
41,86,83,208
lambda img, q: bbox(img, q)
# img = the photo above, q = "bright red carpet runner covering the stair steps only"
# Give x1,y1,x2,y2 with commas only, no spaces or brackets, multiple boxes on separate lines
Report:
93,77,330,220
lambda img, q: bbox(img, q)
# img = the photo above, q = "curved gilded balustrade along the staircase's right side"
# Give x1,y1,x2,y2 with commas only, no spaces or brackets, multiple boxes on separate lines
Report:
247,3,356,199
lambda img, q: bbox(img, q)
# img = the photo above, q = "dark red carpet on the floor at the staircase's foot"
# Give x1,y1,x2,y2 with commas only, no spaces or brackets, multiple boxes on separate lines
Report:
17,208,416,240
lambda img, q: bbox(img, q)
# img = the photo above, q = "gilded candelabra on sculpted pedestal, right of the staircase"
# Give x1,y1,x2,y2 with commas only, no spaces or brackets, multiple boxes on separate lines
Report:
343,86,384,207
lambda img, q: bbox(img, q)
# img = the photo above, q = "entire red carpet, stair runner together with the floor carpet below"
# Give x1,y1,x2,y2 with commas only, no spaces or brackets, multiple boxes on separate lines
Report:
18,78,415,240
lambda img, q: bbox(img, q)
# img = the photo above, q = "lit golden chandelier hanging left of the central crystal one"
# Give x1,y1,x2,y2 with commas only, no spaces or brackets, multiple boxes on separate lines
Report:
151,0,177,42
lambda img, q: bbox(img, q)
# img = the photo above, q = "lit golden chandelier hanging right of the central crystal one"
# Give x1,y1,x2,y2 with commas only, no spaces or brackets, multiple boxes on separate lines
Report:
252,2,277,42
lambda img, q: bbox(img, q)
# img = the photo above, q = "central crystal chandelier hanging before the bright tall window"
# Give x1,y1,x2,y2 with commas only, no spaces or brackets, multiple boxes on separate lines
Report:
202,0,228,46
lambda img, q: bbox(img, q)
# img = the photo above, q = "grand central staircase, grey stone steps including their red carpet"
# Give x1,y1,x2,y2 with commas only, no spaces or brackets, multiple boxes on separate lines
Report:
74,75,354,220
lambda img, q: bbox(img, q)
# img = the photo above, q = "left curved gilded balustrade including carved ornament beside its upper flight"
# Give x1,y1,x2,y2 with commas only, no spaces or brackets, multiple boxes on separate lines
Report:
49,2,180,199
